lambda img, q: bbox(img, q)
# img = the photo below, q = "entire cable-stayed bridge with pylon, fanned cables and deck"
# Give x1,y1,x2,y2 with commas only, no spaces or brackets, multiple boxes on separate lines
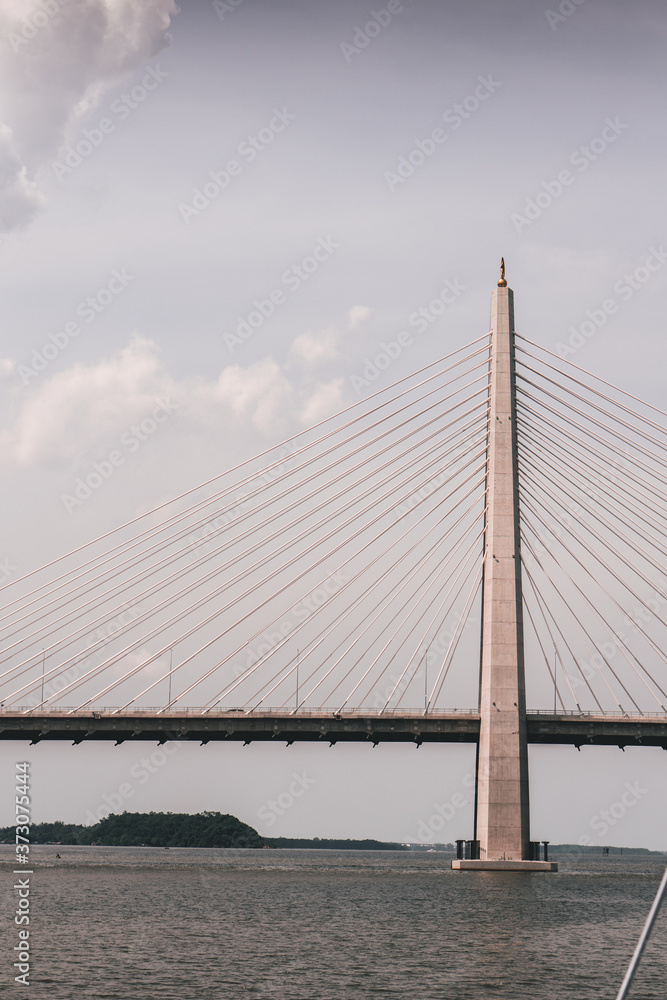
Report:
0,266,667,859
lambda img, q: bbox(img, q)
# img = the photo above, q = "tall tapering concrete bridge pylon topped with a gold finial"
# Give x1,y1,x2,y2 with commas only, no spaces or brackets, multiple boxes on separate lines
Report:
475,267,530,862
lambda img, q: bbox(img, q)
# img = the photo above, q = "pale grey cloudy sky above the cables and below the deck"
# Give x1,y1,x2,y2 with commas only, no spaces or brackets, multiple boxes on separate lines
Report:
0,0,667,849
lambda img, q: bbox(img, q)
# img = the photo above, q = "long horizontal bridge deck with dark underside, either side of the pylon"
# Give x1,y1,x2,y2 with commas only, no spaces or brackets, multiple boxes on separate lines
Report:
0,709,667,750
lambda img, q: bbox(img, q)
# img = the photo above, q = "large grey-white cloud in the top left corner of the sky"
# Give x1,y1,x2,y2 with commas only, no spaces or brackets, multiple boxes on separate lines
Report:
0,0,178,230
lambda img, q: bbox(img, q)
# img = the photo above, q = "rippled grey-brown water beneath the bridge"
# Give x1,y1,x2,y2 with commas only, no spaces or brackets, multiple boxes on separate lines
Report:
0,845,667,1000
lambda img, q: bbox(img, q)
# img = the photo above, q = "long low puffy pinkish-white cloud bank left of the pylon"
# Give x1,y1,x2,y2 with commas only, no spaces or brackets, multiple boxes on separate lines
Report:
0,335,354,468
